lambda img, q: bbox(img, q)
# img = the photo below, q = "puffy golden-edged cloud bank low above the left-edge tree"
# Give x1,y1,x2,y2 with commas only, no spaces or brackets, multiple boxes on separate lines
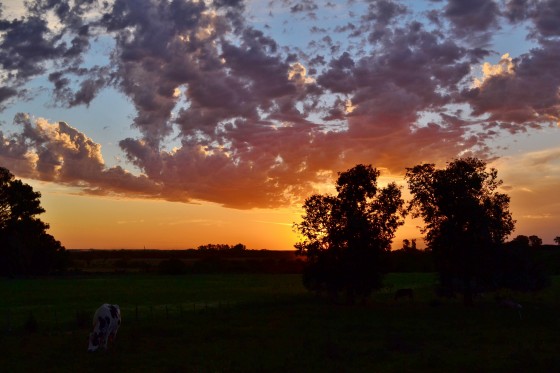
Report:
0,114,161,198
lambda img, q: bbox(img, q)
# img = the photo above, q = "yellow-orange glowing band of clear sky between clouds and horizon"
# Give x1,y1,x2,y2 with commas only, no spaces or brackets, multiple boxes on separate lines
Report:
31,158,558,251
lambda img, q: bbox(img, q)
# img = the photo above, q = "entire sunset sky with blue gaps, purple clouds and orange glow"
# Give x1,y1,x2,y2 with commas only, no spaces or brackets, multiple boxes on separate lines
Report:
0,0,560,250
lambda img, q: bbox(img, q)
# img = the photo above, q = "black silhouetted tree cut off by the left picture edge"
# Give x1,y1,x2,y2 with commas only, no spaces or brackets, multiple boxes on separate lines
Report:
0,167,67,276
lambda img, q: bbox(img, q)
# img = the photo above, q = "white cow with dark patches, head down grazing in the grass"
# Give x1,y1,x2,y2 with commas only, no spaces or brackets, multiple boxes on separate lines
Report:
88,304,121,351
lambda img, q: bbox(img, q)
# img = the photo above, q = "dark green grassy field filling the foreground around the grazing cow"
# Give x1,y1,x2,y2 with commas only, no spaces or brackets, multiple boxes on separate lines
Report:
0,274,560,372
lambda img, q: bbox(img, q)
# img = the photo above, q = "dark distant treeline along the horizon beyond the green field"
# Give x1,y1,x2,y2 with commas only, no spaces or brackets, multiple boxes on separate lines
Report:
63,245,560,275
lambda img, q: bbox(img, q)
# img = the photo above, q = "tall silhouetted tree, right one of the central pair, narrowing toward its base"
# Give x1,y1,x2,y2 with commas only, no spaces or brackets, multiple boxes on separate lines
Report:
405,158,515,305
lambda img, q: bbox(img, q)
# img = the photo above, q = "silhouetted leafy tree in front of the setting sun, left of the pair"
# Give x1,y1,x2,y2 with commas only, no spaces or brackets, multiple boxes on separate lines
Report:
294,164,405,302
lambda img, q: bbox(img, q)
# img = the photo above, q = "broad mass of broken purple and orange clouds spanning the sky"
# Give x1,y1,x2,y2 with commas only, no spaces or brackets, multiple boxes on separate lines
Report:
0,0,560,208
